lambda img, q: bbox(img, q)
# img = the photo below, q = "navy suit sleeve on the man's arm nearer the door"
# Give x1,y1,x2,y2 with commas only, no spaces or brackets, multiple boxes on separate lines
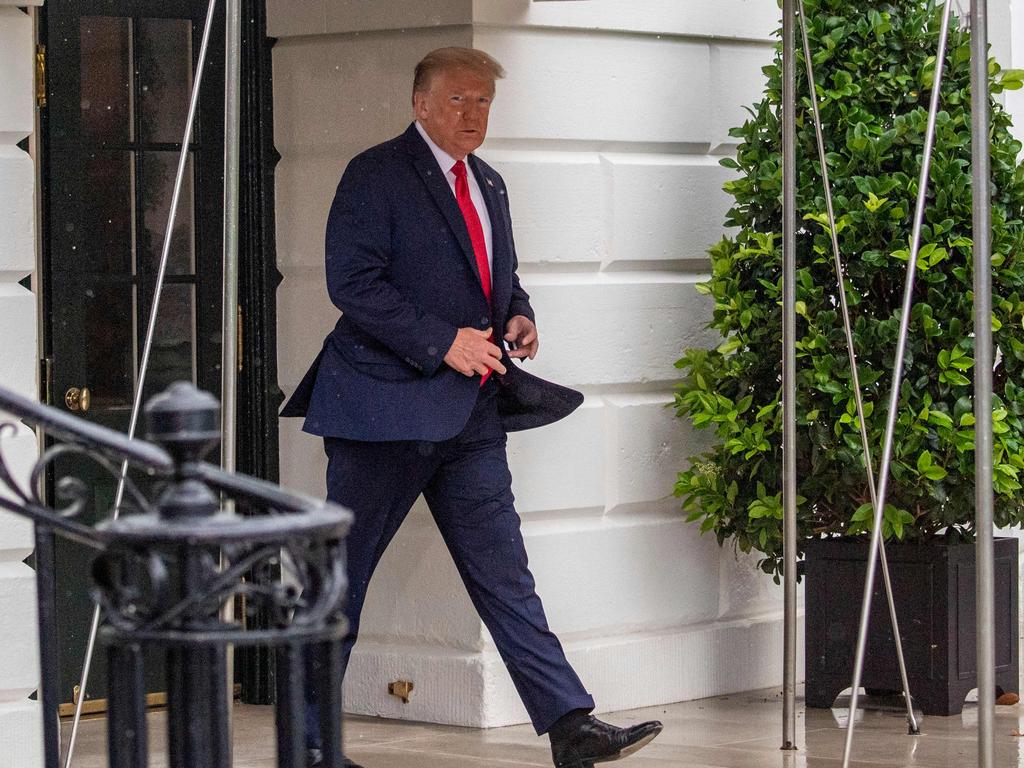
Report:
325,157,459,376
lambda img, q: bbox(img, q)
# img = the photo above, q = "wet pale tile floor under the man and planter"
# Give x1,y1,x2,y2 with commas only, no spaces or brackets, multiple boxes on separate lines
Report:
66,690,1024,768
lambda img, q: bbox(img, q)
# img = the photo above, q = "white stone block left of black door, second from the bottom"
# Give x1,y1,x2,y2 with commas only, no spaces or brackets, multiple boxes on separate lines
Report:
0,562,39,701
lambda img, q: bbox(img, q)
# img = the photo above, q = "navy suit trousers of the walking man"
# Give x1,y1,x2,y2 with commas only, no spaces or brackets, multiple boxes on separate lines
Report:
306,380,594,741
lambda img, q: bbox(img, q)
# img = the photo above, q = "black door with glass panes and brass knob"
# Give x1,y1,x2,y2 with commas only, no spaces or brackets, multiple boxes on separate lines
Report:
43,0,224,716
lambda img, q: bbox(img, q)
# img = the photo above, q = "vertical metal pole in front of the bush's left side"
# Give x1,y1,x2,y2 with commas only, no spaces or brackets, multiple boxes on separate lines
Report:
781,0,797,750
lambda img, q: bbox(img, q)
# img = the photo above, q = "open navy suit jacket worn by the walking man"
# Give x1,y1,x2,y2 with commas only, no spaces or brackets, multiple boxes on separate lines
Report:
281,124,583,441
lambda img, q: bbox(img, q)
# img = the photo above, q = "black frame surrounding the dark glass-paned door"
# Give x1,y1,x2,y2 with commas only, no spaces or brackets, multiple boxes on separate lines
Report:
32,0,284,703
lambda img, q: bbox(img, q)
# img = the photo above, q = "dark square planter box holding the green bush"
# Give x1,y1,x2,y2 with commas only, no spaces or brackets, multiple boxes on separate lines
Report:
804,539,1019,716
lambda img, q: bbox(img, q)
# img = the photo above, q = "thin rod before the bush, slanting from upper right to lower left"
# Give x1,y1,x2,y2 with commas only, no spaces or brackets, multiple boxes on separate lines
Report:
843,0,952,768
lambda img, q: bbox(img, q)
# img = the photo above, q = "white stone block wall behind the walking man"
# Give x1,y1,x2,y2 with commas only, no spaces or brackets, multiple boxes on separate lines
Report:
268,0,781,726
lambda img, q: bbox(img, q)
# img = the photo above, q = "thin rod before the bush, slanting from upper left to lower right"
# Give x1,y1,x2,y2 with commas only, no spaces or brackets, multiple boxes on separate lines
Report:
800,0,921,733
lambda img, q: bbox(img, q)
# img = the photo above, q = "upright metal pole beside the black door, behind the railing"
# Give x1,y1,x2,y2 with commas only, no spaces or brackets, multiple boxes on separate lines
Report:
220,0,242,750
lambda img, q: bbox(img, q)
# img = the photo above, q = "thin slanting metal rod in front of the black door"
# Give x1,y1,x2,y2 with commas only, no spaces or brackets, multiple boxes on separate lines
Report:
65,0,217,768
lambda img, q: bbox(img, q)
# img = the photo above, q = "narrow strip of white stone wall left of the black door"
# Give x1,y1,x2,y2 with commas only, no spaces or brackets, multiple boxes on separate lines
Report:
0,0,42,768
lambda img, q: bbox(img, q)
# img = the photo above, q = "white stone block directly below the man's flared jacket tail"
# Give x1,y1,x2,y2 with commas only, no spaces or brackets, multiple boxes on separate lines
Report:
508,397,609,518
